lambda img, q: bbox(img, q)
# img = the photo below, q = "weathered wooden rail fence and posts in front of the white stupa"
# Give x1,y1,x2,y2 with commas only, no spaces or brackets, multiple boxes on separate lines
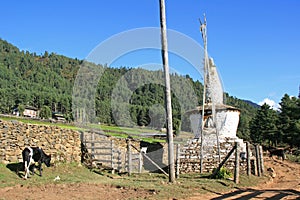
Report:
82,133,264,183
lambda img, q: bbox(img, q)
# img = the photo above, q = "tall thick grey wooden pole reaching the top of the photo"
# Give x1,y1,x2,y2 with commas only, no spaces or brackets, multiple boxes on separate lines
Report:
159,0,175,182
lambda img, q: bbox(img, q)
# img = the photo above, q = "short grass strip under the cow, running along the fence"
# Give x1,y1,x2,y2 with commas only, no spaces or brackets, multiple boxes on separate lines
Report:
0,163,263,199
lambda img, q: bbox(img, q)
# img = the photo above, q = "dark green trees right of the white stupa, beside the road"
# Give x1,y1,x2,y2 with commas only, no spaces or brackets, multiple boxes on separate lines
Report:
249,93,300,148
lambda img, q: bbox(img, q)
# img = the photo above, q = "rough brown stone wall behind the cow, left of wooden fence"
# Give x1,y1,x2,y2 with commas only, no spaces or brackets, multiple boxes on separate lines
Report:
0,120,81,163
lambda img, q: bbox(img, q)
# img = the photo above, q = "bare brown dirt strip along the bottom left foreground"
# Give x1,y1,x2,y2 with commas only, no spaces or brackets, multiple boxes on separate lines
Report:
0,183,151,200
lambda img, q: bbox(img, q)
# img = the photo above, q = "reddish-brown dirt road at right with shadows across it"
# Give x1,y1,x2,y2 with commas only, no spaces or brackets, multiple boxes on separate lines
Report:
189,157,300,200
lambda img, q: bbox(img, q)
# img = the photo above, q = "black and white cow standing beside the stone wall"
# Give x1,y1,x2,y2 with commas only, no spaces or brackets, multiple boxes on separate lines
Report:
22,147,51,179
